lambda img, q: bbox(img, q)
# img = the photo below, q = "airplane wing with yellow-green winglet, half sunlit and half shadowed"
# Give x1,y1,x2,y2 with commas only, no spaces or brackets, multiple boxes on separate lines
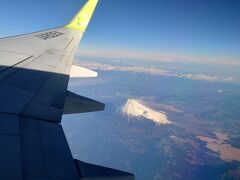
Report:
0,0,134,180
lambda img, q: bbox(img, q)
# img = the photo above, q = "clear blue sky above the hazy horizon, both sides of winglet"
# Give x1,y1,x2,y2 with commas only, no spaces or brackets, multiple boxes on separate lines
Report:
0,0,240,62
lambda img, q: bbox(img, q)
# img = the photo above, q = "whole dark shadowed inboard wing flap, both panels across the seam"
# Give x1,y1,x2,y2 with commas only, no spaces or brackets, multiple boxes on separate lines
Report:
0,113,79,180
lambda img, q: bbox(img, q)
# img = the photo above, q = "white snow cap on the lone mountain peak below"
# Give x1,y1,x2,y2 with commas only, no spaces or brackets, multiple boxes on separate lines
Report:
121,98,171,125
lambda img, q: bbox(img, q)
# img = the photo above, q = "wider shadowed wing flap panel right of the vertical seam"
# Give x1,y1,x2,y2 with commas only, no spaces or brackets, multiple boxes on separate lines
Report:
21,118,79,179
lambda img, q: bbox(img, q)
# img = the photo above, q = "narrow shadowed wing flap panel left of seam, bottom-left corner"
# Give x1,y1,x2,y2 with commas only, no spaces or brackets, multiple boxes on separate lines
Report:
0,113,22,179
